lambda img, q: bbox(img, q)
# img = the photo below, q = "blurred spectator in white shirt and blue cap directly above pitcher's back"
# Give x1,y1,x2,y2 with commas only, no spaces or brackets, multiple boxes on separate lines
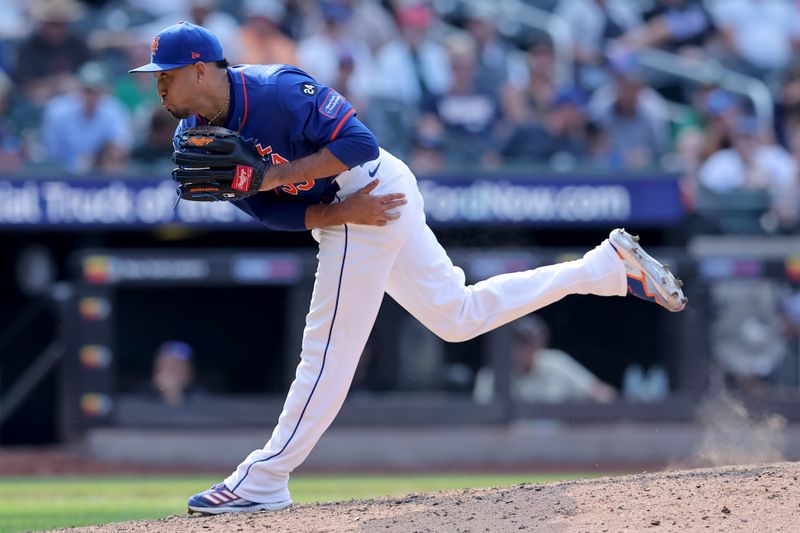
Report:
298,0,373,104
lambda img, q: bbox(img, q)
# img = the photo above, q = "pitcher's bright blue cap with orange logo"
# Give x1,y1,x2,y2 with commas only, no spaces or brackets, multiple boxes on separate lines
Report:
128,21,224,72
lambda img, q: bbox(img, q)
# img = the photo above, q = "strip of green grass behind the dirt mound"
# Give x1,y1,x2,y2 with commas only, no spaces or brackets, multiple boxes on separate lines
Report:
0,474,600,533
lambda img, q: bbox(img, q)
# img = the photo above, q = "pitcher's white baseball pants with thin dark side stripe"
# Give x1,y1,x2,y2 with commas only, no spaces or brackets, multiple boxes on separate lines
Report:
225,150,627,503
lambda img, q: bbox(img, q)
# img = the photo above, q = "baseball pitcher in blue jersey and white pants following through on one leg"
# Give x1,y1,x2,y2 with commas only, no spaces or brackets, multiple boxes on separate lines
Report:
131,22,686,514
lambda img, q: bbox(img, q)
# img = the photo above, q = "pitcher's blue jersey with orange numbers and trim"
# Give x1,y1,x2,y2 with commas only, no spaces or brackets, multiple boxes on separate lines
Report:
175,65,378,231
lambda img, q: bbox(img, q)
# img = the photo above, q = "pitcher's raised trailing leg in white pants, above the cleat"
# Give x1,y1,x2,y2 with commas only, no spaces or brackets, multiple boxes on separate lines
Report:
386,216,628,342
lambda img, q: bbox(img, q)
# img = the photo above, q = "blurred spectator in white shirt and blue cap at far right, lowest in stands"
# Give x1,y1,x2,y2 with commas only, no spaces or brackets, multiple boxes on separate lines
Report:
699,116,798,198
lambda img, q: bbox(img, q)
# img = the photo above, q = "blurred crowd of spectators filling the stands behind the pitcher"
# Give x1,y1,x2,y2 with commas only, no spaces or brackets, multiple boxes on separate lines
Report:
7,0,800,231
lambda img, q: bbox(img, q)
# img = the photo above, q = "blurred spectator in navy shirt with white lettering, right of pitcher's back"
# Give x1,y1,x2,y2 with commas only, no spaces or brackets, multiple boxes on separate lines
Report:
417,34,501,168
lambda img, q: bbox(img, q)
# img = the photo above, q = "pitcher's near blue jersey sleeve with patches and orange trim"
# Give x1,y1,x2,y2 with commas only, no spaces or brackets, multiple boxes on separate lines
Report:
275,71,378,168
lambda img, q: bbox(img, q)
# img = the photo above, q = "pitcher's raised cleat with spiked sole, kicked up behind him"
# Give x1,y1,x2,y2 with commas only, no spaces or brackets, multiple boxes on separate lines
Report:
608,229,688,313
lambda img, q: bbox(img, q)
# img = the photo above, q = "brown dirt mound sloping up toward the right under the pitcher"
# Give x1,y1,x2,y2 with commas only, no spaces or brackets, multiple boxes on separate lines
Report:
65,463,800,533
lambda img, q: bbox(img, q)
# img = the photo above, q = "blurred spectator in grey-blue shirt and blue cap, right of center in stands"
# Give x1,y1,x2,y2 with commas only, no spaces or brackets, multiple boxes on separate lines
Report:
590,56,669,169
